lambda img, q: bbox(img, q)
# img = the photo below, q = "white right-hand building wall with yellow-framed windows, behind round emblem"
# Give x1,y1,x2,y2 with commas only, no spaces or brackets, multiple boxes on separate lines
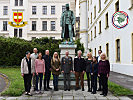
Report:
86,0,133,76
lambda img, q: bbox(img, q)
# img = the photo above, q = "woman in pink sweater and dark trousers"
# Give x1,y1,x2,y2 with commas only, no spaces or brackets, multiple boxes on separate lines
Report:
35,53,45,93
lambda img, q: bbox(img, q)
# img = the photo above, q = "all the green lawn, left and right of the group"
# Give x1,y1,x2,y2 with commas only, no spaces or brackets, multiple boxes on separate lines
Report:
0,67,133,96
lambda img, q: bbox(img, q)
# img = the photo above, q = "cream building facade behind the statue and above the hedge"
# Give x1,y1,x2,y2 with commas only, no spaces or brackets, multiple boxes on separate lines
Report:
0,0,75,40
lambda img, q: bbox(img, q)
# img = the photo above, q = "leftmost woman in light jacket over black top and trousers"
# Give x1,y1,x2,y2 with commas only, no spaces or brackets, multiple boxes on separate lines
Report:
21,51,35,96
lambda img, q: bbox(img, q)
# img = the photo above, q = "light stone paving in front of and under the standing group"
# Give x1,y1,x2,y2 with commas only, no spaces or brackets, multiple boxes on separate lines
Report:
0,81,131,100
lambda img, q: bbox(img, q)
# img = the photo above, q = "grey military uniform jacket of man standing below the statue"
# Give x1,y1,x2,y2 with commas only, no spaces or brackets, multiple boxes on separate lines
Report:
61,56,73,73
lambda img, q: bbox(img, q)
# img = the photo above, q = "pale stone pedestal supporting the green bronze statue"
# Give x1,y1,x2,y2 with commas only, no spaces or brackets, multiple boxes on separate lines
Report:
58,44,77,89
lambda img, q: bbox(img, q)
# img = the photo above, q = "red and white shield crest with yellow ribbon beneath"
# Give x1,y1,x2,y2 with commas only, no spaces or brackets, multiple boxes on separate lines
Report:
8,12,27,27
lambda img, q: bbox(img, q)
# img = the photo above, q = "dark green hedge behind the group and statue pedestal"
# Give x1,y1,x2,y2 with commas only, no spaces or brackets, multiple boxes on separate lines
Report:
0,37,84,66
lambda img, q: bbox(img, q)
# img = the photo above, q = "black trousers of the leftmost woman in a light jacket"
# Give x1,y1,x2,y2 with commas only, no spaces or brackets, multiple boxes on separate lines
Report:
23,74,32,92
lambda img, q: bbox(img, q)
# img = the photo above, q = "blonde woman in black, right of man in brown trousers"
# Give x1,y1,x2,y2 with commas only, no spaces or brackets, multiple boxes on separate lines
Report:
85,52,92,92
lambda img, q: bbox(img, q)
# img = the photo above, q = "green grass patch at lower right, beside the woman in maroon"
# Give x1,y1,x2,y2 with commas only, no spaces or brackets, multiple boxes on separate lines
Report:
108,81,133,96
